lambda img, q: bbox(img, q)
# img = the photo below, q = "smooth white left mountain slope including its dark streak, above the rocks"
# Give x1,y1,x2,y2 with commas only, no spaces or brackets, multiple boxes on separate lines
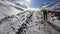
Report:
0,0,25,18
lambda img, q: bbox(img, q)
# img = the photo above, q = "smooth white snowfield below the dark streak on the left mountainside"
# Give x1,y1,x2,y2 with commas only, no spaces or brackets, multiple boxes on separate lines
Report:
0,2,20,18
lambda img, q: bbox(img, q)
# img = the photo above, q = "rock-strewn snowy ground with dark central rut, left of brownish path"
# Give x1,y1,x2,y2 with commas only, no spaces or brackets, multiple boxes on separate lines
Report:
0,11,44,34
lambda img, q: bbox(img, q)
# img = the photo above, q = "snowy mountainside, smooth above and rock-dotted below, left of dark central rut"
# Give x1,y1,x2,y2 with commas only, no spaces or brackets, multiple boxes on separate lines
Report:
0,0,28,34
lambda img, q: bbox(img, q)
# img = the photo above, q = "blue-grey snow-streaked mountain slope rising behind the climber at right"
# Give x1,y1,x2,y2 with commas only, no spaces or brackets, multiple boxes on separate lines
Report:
41,0,60,11
